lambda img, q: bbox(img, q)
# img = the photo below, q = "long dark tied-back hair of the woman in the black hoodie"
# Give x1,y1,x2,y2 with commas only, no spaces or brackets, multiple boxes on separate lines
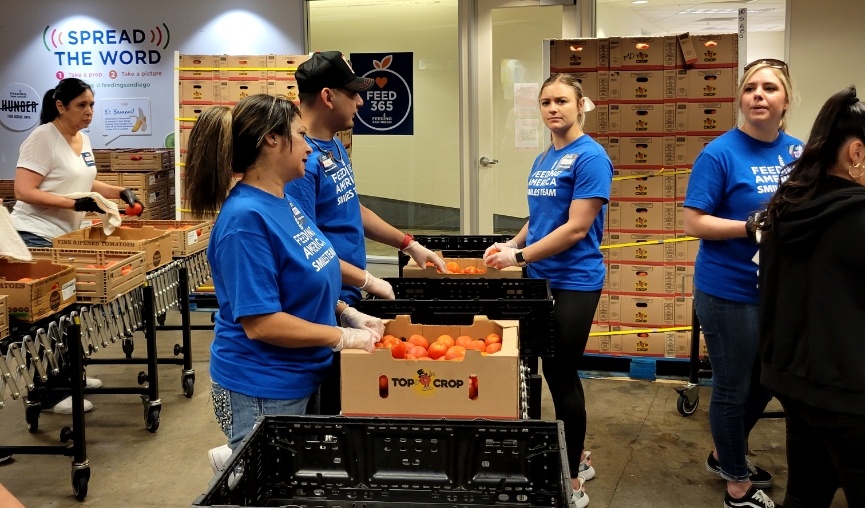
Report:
764,86,865,229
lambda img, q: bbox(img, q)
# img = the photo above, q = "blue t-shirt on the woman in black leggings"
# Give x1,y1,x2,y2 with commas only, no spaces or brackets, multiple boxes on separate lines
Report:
526,134,613,291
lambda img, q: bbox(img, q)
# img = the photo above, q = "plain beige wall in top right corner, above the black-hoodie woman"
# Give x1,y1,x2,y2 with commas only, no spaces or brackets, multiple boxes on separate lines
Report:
787,0,865,139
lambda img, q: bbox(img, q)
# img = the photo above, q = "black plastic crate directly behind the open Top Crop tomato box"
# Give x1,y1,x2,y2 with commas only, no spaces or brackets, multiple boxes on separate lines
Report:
355,278,555,357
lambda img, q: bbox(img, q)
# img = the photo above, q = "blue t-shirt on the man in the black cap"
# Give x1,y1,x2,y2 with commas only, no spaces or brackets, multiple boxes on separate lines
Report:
285,135,366,305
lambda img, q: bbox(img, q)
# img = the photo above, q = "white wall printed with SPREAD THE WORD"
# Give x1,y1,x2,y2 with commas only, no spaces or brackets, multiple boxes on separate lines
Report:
0,0,305,179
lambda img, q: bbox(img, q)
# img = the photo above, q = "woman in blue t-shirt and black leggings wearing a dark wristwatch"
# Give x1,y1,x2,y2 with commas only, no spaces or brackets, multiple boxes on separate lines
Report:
484,74,613,507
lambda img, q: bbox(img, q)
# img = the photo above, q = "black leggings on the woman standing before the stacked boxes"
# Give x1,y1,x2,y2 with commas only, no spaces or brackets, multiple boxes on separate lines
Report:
543,289,601,478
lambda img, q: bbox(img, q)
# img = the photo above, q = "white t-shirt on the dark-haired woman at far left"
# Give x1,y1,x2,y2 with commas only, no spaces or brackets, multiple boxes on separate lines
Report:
12,122,96,239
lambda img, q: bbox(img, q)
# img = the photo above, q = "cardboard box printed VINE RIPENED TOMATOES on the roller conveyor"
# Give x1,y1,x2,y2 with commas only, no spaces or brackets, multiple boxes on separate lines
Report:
54,226,171,271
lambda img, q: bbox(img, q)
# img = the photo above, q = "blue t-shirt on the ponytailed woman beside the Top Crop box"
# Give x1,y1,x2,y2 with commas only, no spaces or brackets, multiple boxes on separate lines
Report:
207,183,340,399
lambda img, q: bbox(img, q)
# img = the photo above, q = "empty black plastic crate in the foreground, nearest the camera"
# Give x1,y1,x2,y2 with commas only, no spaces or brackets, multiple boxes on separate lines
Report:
192,416,572,508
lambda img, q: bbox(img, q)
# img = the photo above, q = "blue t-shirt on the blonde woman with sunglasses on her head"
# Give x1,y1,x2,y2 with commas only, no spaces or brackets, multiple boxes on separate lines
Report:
685,128,803,303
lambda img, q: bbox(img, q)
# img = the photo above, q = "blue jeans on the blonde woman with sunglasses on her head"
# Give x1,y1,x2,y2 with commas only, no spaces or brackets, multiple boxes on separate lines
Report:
694,290,772,482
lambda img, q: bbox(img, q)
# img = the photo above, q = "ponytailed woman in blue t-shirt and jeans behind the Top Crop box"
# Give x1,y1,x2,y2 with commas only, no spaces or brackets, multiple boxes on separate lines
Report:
186,95,384,472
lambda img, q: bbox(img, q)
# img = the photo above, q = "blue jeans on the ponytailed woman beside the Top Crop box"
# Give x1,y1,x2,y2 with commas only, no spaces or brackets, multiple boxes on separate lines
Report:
210,381,309,451
